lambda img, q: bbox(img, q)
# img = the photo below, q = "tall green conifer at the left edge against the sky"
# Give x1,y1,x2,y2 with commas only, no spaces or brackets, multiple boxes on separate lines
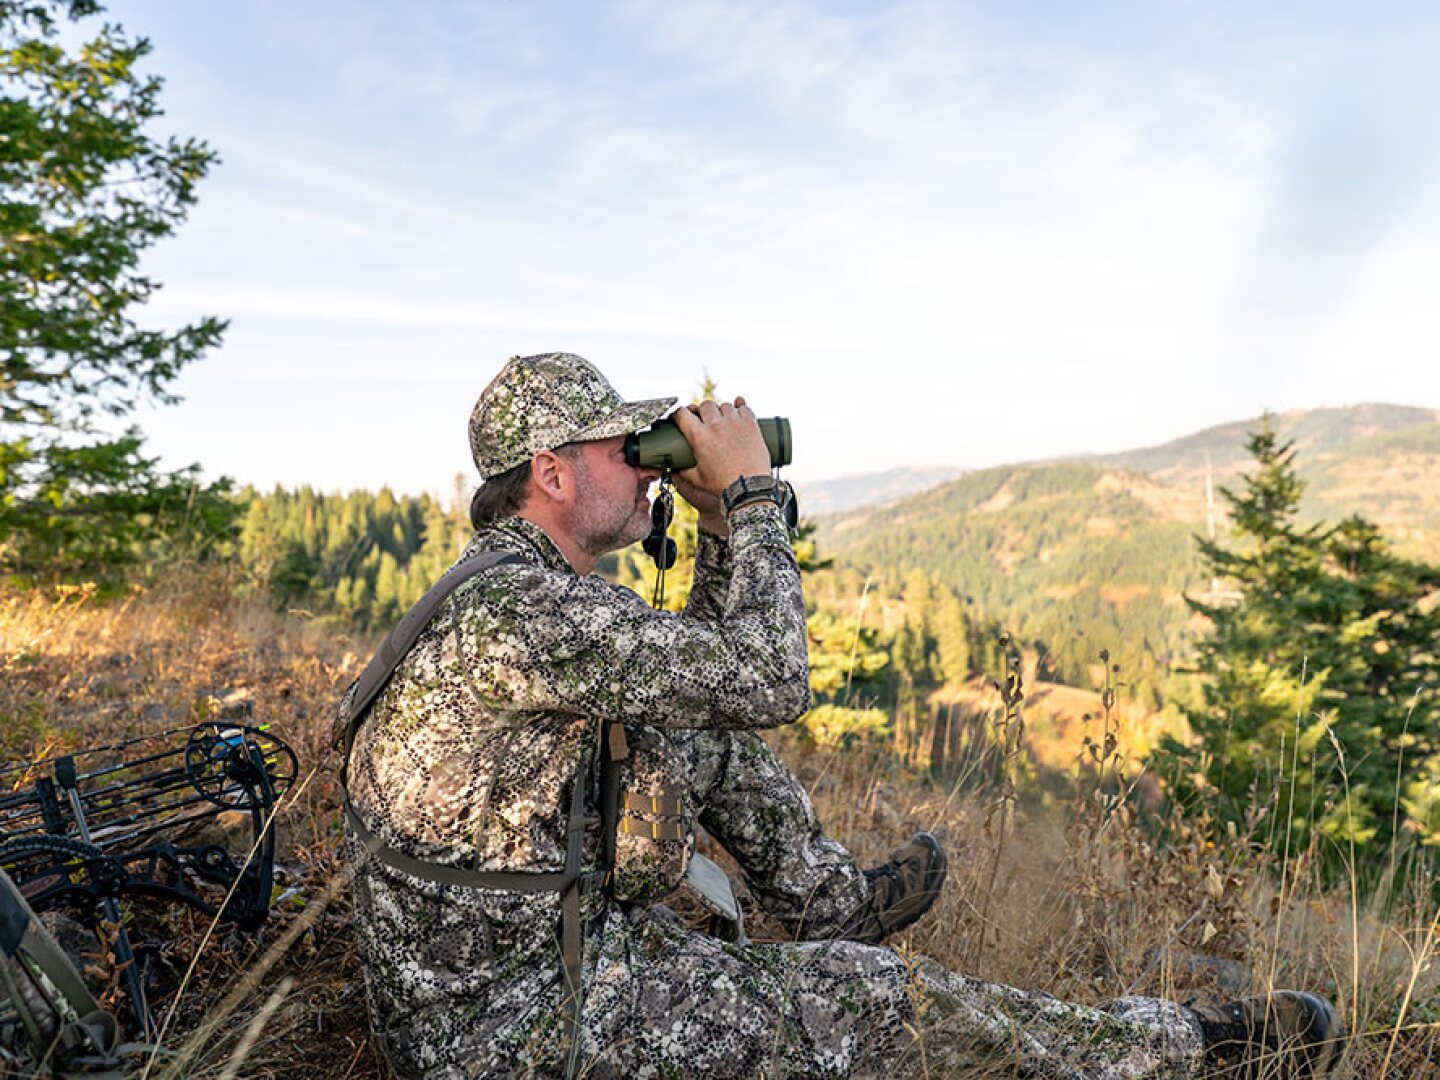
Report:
0,0,236,577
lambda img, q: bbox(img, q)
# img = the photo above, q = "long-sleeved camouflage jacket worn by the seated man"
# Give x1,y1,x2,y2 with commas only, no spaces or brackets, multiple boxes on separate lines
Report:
343,504,809,1076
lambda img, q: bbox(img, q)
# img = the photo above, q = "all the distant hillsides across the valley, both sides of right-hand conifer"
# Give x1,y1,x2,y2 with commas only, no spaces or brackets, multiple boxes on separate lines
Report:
816,405,1440,706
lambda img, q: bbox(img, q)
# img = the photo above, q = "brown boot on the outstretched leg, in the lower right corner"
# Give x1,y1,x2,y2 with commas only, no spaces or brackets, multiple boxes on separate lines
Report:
1191,991,1345,1080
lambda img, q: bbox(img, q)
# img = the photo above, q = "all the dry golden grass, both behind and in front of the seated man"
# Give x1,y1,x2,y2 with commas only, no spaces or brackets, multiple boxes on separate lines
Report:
0,572,1440,1077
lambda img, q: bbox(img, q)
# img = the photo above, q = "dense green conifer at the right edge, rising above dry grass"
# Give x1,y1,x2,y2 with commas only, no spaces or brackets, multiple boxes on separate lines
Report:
1166,416,1440,869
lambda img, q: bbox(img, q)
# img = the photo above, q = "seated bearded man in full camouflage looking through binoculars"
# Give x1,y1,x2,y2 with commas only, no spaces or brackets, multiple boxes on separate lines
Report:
341,353,1336,1077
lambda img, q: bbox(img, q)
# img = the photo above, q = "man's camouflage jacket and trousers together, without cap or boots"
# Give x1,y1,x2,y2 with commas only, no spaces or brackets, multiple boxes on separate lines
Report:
342,503,1200,1080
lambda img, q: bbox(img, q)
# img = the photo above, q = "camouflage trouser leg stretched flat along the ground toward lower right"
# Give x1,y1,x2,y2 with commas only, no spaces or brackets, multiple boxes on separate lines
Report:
581,907,1204,1080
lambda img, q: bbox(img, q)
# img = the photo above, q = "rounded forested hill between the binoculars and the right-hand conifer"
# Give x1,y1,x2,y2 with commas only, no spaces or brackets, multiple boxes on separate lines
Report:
818,464,1202,691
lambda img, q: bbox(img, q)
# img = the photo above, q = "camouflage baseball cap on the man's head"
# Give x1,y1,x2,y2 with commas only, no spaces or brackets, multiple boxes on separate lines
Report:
469,353,675,480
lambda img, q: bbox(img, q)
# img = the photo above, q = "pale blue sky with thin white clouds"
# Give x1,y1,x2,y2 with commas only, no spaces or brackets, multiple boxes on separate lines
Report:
87,0,1440,492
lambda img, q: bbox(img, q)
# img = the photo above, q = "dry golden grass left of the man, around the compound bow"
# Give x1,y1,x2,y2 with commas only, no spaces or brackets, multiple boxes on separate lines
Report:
0,572,382,1077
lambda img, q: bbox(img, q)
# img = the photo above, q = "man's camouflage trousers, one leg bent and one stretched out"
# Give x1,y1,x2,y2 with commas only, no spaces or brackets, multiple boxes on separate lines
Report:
580,732,1201,1080
